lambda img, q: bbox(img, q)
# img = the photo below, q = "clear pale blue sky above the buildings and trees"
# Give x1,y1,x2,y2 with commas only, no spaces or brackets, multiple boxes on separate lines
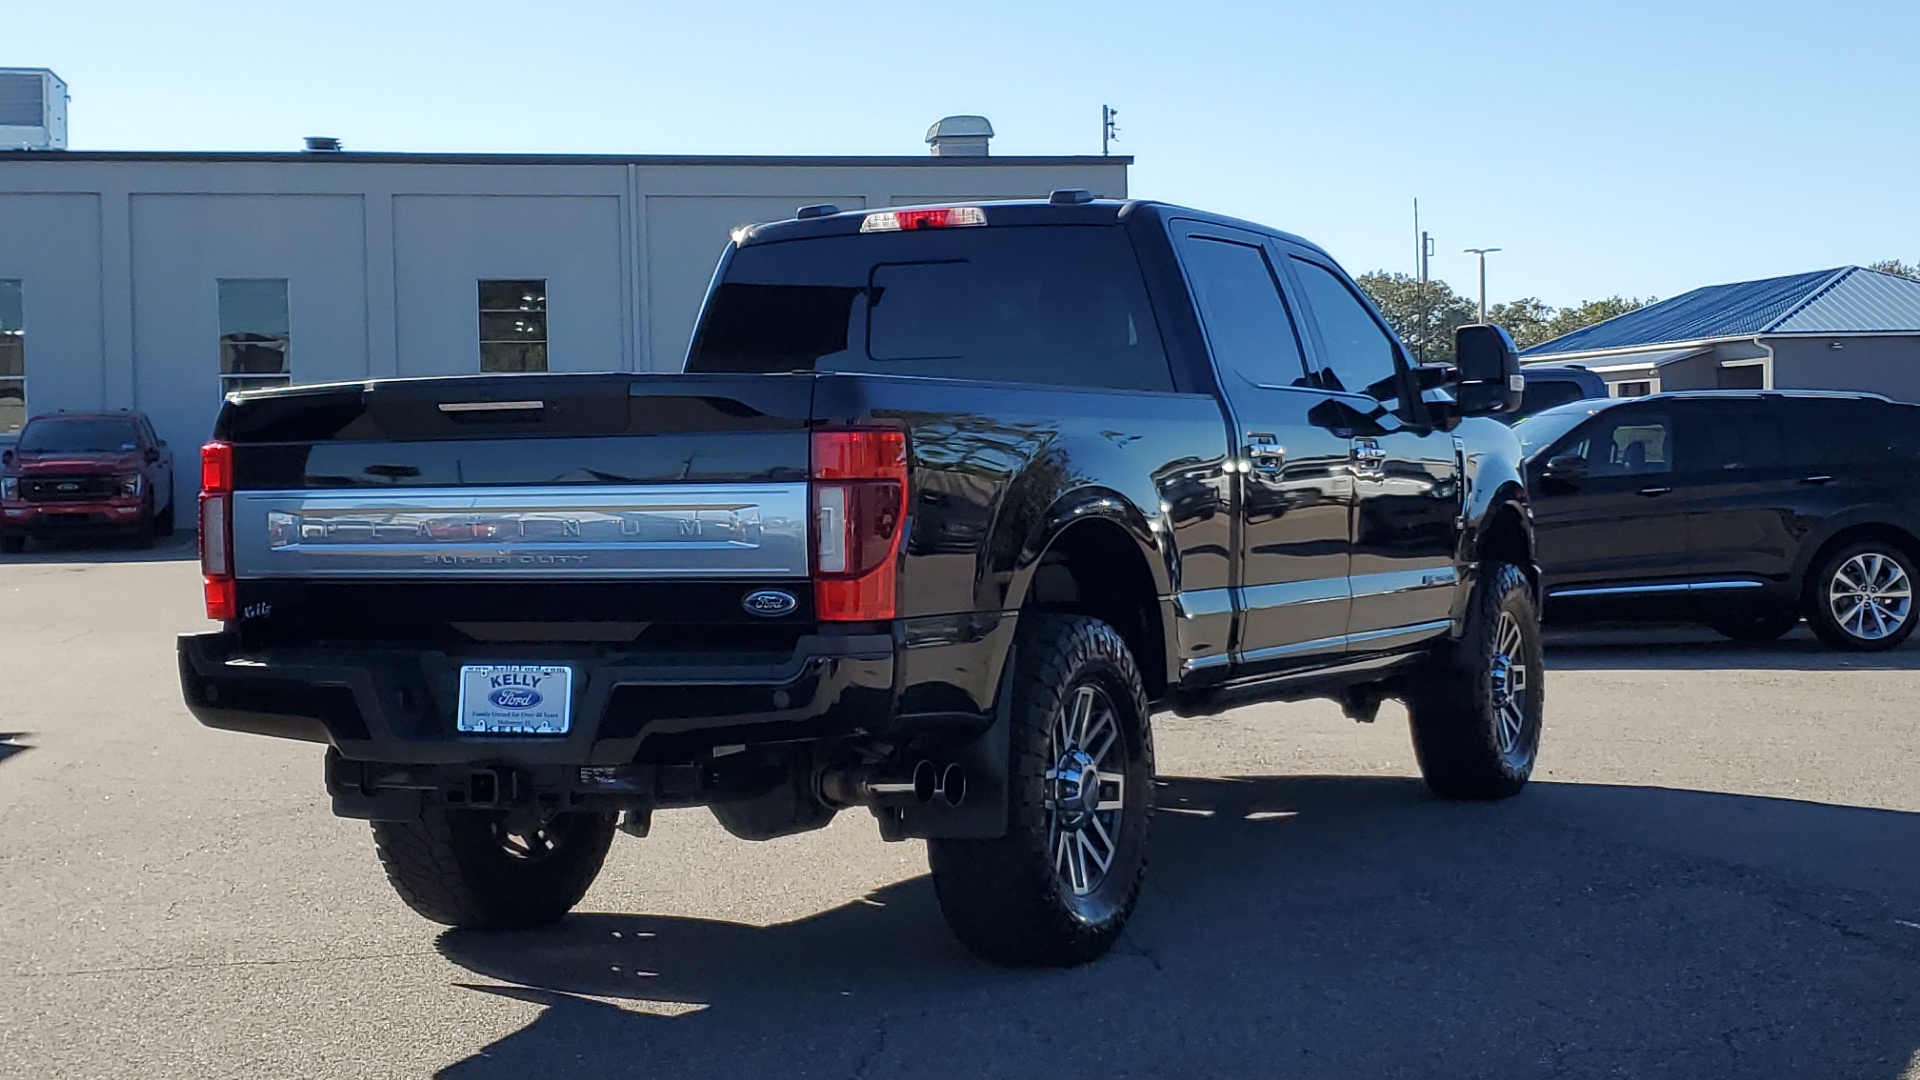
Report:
15,0,1920,304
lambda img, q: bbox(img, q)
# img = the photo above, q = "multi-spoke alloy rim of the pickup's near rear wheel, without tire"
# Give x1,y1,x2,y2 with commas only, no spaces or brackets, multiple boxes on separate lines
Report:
1046,686,1127,896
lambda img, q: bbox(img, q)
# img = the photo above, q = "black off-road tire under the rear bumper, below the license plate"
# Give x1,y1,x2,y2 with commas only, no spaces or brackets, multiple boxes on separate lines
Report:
372,809,614,930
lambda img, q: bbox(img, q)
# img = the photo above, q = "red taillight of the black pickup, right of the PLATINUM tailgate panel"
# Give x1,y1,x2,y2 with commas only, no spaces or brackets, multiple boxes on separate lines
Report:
812,429,906,623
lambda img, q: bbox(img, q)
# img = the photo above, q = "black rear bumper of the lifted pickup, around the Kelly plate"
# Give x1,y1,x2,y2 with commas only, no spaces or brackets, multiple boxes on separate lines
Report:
179,630,895,767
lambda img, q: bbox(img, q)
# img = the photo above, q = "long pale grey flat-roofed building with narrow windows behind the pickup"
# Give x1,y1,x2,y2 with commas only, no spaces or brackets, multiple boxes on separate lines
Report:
0,133,1131,507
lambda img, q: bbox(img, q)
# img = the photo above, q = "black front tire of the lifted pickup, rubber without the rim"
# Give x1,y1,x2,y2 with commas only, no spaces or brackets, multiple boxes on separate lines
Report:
1407,563,1546,799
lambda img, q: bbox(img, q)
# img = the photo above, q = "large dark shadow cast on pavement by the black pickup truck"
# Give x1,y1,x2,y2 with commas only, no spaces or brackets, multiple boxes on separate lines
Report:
440,776,1920,1080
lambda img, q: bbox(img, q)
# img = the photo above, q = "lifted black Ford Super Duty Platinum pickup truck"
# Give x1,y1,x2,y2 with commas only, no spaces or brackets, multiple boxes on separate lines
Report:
179,192,1544,965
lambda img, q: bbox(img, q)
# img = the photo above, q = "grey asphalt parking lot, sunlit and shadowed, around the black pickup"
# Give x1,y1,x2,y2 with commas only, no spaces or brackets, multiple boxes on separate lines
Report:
0,546,1920,1080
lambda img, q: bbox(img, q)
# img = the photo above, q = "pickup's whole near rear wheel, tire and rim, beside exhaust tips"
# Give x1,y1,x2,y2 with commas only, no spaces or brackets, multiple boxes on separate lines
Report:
927,615,1154,967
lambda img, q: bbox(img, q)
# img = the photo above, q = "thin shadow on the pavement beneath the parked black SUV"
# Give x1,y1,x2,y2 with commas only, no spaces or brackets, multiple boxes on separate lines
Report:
1546,623,1920,671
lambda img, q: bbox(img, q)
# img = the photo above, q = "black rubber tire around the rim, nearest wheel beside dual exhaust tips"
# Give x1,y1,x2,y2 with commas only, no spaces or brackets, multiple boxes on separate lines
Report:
927,613,1154,967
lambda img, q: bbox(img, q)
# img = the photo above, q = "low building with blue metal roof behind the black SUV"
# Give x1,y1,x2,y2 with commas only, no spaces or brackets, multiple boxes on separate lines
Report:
1521,267,1920,402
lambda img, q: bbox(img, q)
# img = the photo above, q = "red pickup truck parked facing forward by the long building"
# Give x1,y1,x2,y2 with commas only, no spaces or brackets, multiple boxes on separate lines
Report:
0,411,175,553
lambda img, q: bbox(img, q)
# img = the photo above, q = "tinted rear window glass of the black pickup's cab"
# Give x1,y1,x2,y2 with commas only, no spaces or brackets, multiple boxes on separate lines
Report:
687,225,1173,390
